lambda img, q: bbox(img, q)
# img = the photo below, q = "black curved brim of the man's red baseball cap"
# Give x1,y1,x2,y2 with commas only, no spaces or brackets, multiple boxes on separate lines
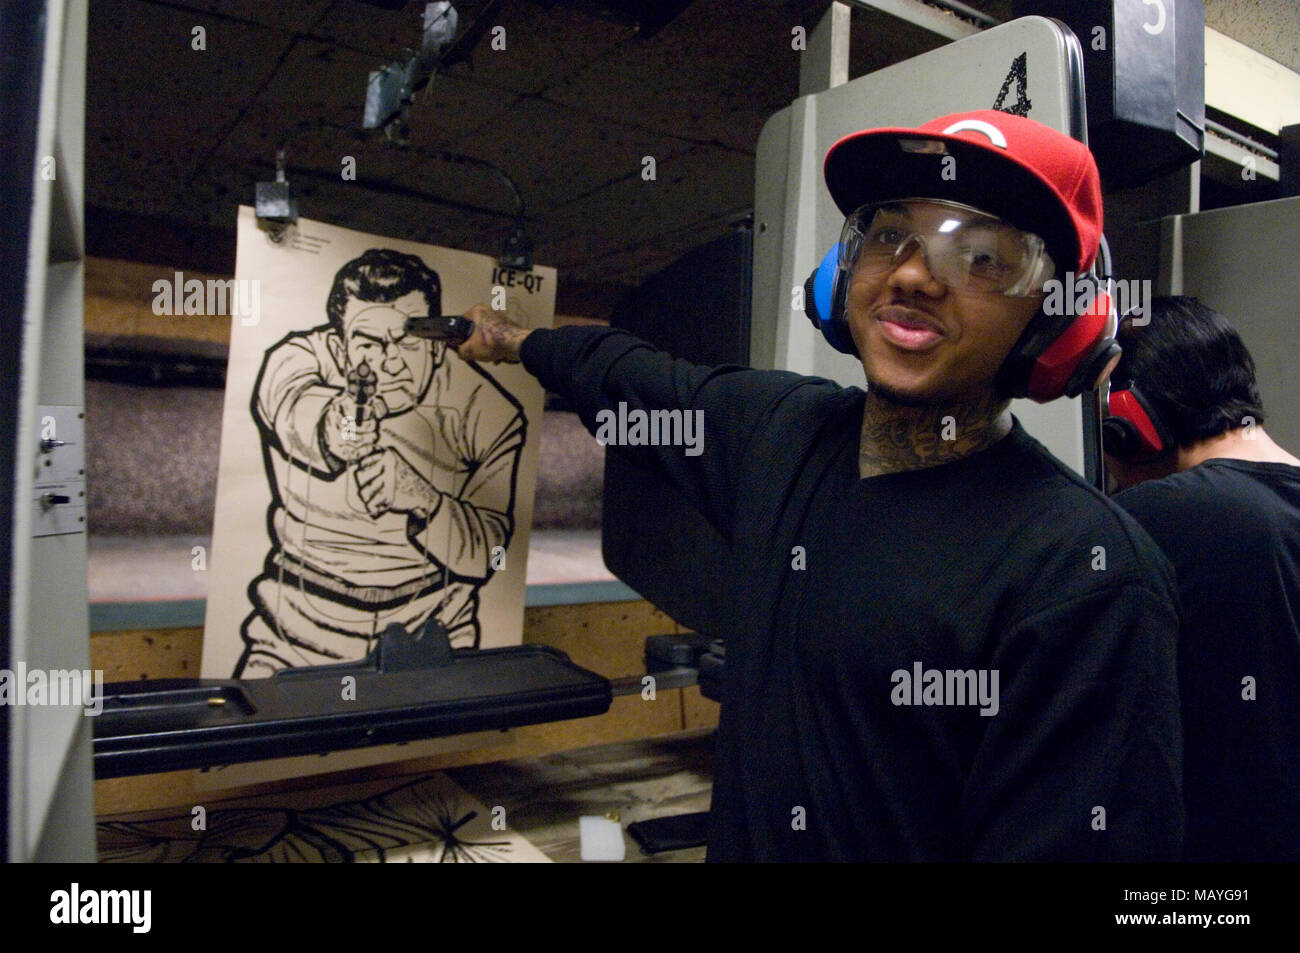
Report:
824,129,1080,269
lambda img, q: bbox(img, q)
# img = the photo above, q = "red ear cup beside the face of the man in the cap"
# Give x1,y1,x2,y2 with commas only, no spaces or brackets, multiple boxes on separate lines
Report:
998,274,1119,403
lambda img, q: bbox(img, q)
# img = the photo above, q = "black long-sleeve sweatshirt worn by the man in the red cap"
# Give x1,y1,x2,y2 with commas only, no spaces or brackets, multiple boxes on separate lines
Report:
520,328,1182,861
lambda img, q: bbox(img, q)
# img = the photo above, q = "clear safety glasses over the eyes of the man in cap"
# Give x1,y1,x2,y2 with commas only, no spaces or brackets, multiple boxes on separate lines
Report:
840,199,1056,298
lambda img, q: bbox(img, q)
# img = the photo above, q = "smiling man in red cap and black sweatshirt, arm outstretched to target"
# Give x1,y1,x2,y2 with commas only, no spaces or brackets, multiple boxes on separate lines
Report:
460,112,1182,861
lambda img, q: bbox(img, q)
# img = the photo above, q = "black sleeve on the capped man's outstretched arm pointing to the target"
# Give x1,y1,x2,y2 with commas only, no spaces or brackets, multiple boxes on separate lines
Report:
520,325,803,538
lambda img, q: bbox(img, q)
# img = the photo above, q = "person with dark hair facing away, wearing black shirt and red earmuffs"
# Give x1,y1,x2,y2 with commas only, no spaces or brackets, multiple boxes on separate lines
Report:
1102,298,1300,861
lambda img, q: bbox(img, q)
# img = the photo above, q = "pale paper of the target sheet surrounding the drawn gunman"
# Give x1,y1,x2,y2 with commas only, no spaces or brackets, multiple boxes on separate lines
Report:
203,207,555,677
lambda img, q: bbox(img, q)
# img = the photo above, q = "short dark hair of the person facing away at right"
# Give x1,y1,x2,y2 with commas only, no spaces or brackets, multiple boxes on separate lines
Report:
1110,296,1264,447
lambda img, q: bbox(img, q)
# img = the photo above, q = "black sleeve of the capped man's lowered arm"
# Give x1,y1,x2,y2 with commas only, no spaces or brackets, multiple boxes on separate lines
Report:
962,580,1183,861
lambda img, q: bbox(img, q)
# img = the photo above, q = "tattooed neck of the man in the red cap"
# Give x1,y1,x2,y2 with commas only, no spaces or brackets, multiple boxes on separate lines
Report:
858,391,1011,478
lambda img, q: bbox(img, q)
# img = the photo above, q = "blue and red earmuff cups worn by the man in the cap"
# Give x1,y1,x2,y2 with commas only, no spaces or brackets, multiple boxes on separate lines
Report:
803,244,1121,403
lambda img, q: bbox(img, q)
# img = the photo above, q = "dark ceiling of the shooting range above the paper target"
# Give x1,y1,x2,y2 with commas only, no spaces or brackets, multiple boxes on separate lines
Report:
86,0,1010,316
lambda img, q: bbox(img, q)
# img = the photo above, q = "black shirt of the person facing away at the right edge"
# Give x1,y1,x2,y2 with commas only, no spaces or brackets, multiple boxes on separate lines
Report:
1117,459,1300,862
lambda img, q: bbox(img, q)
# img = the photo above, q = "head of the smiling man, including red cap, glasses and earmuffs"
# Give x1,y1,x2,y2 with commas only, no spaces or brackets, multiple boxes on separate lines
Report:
809,111,1119,400
